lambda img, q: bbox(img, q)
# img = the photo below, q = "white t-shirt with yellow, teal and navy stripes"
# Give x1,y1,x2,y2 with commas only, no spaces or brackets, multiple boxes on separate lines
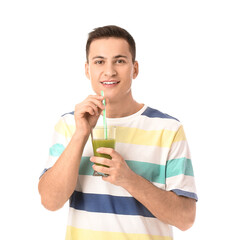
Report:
41,106,197,240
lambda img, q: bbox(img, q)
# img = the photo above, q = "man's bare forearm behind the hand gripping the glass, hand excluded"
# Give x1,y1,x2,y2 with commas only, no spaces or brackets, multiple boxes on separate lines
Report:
123,173,196,231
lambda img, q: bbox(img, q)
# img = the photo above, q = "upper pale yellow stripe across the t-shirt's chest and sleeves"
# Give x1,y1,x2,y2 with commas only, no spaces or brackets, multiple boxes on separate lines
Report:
55,120,186,147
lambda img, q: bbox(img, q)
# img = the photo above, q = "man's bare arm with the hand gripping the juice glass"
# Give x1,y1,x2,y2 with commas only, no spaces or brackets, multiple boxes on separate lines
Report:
91,148,196,231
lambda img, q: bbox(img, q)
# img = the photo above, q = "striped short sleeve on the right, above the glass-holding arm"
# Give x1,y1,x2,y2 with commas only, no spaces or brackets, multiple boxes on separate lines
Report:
166,126,198,201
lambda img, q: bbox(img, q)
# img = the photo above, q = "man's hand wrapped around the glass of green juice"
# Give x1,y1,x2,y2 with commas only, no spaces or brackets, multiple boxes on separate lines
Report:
90,147,133,186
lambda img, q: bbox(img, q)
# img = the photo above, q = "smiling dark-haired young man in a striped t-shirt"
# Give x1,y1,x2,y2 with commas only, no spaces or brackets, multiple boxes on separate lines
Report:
39,26,197,240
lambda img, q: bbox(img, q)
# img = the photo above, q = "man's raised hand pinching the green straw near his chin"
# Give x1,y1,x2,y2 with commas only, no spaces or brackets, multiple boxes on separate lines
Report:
74,95,105,135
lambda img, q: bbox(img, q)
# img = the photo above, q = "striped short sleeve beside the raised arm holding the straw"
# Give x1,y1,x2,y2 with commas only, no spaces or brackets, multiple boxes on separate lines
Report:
40,117,71,178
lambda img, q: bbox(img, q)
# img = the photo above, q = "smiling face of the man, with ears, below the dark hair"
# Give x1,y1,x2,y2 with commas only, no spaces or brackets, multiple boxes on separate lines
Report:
85,38,138,101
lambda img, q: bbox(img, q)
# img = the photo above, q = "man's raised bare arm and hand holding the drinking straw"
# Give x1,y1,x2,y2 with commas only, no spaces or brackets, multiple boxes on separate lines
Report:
38,95,104,211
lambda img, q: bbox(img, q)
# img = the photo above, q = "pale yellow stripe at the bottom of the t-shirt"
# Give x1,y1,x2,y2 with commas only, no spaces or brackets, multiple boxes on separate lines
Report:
66,226,172,240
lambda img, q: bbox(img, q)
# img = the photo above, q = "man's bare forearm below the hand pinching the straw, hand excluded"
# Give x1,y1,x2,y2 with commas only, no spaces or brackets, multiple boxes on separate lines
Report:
38,134,88,211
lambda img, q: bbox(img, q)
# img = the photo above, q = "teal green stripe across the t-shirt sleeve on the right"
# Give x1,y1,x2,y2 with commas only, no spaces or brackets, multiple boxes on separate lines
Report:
166,158,194,178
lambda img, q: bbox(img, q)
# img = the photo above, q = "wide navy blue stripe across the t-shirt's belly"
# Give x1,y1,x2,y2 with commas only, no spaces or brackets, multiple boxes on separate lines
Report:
70,191,154,218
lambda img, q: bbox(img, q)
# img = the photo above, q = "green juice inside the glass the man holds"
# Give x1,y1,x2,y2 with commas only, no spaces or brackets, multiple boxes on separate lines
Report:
92,139,116,167
